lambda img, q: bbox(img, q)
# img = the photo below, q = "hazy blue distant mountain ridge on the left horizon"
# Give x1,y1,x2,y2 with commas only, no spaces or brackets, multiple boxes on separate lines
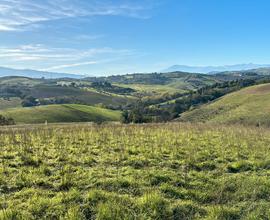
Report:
0,67,84,79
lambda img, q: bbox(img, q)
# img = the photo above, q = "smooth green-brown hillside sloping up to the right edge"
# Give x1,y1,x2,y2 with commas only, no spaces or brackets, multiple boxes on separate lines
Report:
180,84,270,126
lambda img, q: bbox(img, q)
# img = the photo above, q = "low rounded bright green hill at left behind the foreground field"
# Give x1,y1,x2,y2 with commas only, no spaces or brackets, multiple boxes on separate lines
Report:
0,104,121,124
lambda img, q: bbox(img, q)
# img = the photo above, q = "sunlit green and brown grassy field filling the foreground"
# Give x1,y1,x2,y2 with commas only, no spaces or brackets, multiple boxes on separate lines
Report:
0,123,270,219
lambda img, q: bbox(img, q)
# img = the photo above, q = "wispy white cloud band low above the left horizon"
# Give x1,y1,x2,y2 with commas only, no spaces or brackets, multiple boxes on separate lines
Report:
0,44,135,71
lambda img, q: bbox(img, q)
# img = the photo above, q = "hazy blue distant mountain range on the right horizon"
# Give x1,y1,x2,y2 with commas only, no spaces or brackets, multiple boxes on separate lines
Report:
162,63,270,73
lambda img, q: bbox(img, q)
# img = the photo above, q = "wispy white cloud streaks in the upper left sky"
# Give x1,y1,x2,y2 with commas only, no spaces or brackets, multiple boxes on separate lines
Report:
0,0,153,31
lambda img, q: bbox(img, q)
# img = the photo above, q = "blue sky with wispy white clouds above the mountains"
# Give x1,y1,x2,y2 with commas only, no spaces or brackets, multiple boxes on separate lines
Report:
0,0,270,76
